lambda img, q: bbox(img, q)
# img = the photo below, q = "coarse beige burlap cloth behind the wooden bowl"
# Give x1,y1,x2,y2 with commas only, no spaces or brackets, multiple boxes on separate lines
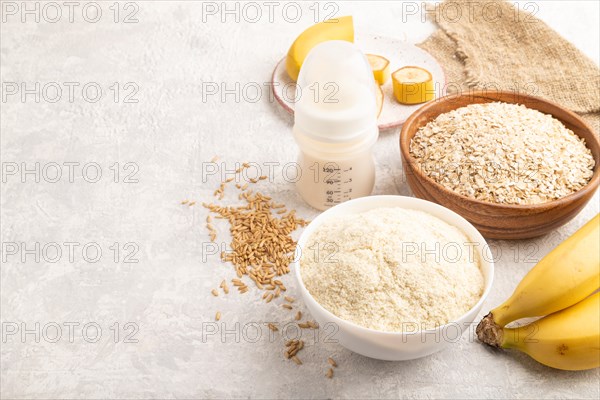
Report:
419,0,600,132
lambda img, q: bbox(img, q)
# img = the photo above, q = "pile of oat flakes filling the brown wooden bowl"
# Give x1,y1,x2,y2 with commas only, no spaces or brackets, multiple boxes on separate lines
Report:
410,103,594,204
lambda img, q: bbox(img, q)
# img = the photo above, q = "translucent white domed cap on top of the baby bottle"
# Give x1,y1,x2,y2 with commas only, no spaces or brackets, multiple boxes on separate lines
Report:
294,40,379,143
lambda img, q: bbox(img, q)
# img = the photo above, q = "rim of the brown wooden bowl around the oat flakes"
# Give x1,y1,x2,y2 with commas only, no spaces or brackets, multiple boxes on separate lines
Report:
400,90,600,211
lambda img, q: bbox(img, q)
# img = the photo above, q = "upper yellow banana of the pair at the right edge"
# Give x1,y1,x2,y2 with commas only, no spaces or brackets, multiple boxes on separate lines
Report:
486,214,600,329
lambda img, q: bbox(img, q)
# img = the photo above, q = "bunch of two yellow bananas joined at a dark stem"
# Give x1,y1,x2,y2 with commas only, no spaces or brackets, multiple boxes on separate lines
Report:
476,214,600,370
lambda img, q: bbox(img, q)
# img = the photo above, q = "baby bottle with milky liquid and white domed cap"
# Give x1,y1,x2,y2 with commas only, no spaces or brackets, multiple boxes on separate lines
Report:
293,40,379,210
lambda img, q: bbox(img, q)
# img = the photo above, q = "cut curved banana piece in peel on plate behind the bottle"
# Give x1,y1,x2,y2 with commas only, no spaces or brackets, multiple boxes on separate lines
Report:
285,16,354,81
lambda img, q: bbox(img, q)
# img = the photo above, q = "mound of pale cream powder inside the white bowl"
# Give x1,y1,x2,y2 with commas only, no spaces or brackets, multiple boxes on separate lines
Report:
300,208,484,332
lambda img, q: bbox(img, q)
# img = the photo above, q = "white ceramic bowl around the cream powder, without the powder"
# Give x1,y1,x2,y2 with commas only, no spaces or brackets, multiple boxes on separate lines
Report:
293,196,494,361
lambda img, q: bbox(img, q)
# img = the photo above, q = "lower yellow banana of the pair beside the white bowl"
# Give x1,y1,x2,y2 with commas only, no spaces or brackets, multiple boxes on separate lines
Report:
482,292,600,371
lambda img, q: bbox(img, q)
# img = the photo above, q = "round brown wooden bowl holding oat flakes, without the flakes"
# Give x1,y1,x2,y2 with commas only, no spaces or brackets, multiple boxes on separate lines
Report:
400,91,600,239
